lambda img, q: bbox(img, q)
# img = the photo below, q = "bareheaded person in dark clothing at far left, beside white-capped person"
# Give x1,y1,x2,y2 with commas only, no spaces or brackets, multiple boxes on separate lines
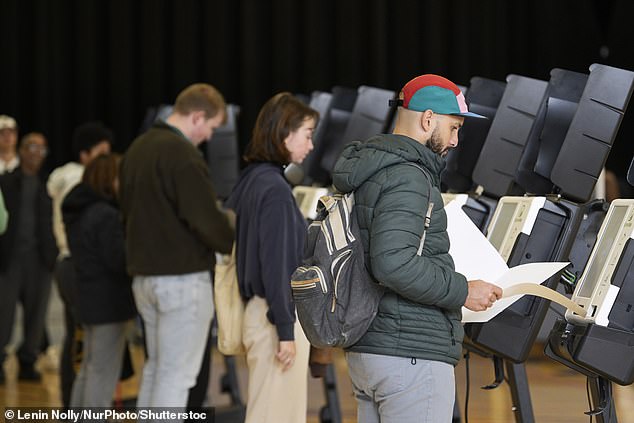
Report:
0,133,57,381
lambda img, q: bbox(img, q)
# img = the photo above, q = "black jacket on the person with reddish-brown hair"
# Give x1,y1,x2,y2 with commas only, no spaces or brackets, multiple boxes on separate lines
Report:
62,183,136,325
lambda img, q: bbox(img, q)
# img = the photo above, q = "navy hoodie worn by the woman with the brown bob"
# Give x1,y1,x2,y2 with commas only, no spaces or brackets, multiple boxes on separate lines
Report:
226,163,306,341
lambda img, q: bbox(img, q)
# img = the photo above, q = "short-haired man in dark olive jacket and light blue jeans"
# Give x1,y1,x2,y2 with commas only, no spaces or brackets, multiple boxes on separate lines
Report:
120,84,234,409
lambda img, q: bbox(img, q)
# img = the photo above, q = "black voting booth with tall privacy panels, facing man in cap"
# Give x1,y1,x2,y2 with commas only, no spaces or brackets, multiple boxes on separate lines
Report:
452,64,634,421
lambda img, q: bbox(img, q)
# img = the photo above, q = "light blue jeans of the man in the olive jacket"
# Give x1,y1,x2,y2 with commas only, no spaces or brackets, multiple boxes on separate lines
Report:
132,272,214,416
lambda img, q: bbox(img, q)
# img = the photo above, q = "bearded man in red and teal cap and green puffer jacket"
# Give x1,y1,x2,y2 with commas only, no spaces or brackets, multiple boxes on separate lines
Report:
333,75,502,423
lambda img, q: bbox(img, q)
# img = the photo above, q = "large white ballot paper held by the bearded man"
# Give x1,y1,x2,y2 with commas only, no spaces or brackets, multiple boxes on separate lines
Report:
445,201,568,323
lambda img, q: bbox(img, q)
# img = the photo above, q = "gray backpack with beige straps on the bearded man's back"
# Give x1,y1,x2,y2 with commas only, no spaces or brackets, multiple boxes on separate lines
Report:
291,193,383,348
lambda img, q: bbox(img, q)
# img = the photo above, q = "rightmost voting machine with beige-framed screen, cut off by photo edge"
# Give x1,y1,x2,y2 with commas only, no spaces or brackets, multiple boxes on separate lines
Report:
546,199,634,385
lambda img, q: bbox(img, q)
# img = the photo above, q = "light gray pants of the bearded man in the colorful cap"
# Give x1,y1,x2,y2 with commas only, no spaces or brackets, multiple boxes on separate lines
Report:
346,352,455,423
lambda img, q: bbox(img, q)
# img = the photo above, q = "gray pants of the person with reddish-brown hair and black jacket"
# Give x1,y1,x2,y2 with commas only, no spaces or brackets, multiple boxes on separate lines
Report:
70,320,132,407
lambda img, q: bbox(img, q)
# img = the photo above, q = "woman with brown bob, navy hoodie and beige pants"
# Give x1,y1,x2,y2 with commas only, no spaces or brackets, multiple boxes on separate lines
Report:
226,93,319,423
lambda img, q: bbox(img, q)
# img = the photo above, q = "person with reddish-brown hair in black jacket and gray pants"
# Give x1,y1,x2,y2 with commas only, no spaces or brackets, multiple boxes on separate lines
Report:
62,154,136,407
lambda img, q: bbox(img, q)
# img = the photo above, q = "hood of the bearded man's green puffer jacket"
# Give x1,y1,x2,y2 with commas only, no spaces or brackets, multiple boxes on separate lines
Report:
332,134,445,193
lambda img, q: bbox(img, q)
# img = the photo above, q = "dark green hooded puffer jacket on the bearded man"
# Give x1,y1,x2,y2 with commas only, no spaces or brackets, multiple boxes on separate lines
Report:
333,135,467,365
